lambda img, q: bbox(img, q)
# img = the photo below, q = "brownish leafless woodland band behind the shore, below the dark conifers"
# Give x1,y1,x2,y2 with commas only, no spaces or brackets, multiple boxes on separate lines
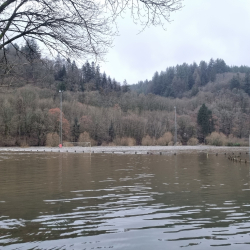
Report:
0,80,250,146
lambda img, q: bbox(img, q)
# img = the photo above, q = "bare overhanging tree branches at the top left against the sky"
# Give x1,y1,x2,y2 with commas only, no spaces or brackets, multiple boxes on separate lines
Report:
0,0,182,58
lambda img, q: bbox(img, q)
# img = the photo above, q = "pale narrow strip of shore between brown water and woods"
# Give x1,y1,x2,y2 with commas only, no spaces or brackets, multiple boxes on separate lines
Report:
0,145,249,155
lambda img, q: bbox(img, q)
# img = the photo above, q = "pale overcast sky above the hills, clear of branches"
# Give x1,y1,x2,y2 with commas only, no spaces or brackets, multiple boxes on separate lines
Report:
101,0,250,84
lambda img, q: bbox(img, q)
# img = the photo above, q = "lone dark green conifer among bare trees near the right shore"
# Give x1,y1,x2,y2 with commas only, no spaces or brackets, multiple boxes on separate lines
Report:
197,104,213,142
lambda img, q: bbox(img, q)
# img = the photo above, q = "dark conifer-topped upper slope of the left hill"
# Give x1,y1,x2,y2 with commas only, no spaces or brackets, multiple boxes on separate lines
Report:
0,39,129,94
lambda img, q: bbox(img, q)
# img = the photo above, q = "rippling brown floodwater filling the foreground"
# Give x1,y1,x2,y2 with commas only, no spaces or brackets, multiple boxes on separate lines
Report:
0,153,250,250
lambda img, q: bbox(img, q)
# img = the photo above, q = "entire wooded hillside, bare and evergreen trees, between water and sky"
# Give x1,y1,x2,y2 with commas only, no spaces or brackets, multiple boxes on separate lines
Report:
0,40,250,146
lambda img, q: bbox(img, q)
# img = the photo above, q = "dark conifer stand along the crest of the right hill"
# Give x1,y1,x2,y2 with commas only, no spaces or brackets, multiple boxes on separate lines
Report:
131,59,250,98
